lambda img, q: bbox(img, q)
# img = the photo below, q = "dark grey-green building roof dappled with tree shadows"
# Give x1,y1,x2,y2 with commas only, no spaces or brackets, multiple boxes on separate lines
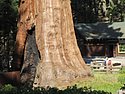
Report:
75,22,125,39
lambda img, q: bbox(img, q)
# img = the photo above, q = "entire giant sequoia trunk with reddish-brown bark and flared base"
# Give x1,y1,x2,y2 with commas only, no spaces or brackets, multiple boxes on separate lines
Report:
15,0,90,86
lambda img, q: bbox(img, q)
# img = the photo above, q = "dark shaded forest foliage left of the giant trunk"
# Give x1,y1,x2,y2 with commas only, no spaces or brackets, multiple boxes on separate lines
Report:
0,0,18,71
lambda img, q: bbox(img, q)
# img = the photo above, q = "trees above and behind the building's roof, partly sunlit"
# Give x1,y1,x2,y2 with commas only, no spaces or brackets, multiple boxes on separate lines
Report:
71,0,125,23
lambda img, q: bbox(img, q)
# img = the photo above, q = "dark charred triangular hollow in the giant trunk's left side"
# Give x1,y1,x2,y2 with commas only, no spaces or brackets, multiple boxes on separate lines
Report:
21,26,40,85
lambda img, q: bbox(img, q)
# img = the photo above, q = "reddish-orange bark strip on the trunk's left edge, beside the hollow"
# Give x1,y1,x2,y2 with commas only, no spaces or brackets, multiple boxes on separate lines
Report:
13,0,34,70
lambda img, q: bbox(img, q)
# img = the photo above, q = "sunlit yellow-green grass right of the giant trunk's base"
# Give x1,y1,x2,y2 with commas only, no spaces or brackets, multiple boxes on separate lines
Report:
77,73,122,94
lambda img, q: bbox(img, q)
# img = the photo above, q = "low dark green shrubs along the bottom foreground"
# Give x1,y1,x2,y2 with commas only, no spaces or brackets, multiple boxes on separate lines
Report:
0,85,111,94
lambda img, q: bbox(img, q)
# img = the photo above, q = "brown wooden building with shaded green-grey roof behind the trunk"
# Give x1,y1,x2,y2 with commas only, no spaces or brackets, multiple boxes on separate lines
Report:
75,22,125,57
